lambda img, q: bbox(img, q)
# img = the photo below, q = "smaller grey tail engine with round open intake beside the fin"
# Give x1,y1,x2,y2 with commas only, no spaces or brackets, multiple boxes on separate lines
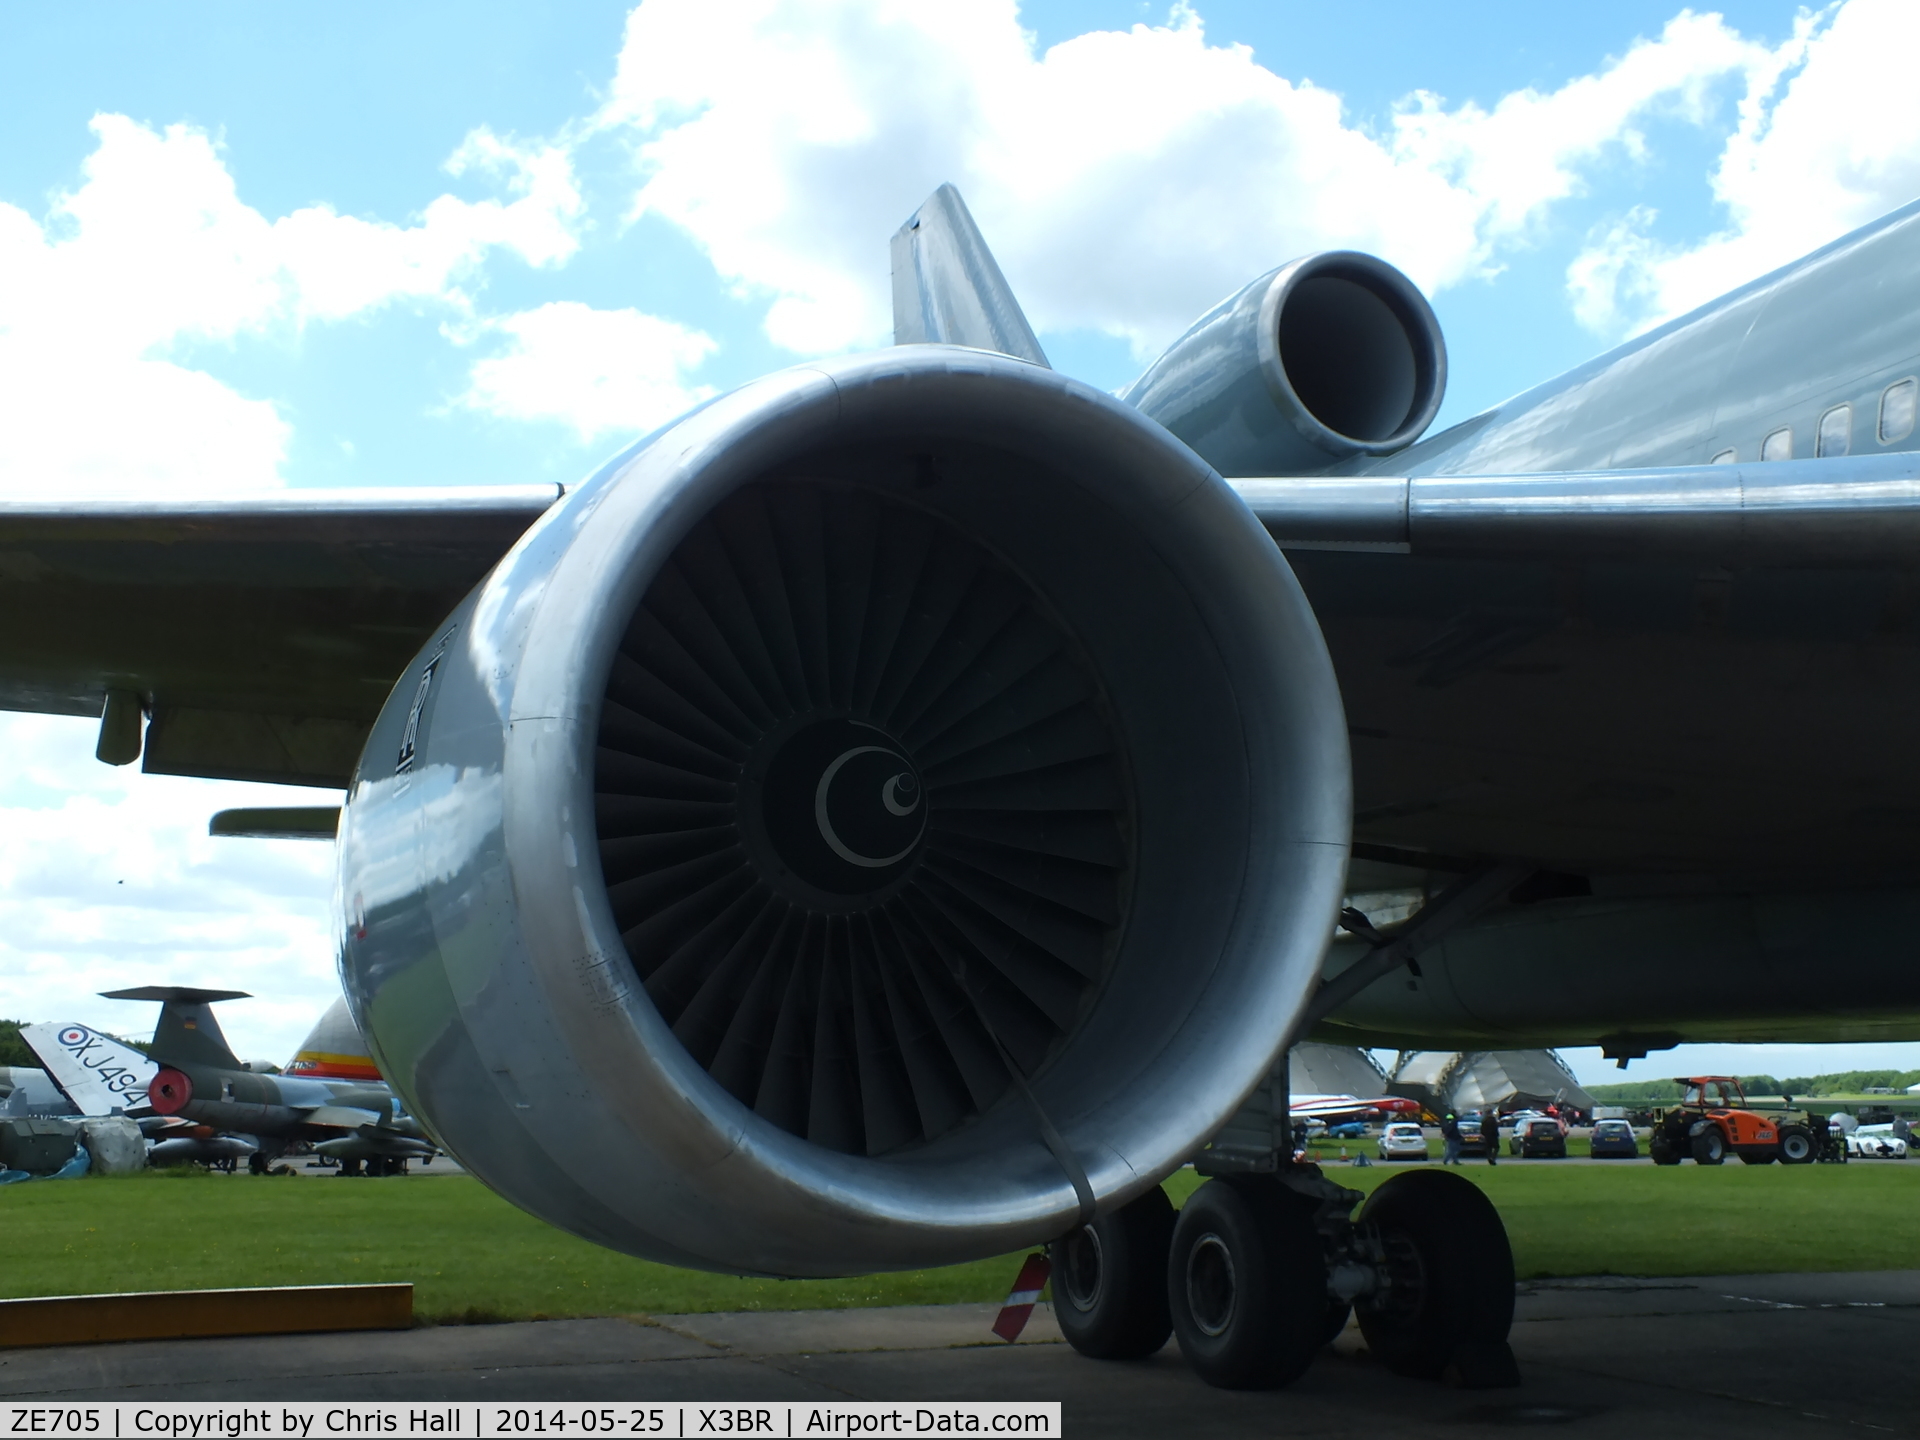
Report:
1123,250,1446,476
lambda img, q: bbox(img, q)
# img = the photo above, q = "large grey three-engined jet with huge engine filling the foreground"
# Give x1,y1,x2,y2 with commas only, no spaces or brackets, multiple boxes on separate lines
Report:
11,186,1920,1386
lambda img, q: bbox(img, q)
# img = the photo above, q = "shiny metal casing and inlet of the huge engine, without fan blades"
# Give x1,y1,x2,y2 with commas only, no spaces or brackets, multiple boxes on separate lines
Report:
338,346,1348,1275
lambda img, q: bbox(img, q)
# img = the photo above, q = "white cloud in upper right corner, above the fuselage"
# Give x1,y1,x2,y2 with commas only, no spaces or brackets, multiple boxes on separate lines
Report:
1567,0,1920,334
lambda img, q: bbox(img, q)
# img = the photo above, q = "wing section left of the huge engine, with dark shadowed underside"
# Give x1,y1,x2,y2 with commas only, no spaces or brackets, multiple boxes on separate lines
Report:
0,486,561,787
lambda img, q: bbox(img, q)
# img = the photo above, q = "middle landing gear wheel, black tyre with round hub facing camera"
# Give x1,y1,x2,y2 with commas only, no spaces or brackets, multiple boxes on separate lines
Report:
1167,1175,1329,1390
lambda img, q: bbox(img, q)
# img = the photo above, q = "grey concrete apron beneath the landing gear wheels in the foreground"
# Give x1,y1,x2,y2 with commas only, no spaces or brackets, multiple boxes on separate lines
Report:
0,1271,1920,1440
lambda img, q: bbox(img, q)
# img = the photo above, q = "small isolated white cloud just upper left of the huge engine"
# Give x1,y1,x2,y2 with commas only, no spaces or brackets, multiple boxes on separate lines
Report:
461,300,714,440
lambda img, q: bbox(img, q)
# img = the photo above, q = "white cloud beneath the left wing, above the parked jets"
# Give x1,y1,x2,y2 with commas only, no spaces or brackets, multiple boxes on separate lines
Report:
0,716,340,1064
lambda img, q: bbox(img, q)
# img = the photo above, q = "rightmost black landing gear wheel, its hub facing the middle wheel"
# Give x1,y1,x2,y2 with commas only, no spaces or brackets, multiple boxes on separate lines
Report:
1354,1169,1521,1390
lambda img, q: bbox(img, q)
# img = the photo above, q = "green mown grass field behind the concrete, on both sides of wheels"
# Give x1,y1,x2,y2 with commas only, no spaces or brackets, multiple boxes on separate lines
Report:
0,1160,1920,1321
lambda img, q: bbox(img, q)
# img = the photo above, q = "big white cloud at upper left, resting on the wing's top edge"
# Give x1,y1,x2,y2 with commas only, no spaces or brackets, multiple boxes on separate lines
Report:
0,115,582,495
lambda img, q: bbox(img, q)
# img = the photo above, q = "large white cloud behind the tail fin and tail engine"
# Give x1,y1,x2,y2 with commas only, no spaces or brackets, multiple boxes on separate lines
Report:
597,0,1766,355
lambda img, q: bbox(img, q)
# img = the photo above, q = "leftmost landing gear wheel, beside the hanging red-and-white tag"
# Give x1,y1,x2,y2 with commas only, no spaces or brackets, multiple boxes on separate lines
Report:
1048,1185,1175,1359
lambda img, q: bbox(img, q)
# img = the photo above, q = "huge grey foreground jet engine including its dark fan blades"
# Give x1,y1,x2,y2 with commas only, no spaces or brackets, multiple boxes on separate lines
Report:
338,346,1348,1275
